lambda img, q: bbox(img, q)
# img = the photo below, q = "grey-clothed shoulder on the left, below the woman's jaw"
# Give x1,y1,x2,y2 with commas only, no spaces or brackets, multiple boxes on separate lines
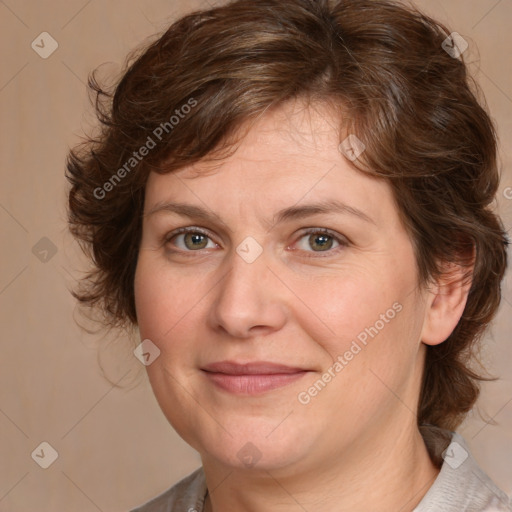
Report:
130,467,206,512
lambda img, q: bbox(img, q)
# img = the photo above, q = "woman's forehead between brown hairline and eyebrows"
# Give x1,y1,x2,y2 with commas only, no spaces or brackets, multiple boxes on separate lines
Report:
145,101,393,227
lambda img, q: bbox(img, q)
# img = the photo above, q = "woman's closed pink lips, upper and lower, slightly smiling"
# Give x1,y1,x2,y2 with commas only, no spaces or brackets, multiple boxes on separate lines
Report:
201,361,309,395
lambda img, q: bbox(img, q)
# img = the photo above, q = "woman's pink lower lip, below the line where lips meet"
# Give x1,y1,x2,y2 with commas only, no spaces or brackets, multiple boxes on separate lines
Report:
204,371,308,395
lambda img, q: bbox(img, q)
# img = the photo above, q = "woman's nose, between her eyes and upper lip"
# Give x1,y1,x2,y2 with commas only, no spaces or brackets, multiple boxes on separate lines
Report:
210,244,290,339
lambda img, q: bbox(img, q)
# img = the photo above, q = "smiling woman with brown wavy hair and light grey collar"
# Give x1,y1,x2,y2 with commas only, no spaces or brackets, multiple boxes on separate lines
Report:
67,0,512,512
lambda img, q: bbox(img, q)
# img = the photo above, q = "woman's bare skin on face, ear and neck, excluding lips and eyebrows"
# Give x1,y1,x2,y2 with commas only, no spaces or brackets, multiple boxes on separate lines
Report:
135,101,467,512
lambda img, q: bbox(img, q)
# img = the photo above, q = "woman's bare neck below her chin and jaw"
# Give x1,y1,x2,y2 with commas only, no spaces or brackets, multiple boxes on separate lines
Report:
203,428,439,512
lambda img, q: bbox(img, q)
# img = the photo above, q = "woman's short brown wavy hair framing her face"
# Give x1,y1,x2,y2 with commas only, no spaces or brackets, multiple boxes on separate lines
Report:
66,0,507,430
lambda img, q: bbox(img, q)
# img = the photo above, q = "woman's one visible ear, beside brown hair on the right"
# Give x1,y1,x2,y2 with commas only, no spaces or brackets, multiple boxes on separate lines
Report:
421,258,473,345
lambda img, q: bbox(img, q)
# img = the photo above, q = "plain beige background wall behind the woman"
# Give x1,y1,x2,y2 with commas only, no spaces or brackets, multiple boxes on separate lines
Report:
0,0,512,512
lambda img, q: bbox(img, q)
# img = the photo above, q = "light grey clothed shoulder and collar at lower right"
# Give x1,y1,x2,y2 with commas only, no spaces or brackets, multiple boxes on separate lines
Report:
414,432,512,512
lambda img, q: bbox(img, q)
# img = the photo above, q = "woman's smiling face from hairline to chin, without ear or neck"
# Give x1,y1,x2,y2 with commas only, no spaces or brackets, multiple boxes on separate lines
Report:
135,103,428,476
